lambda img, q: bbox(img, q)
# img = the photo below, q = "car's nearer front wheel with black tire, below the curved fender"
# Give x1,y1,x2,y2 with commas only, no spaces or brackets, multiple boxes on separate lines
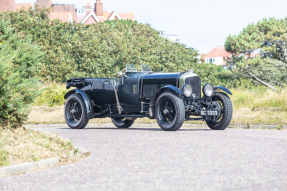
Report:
155,92,185,131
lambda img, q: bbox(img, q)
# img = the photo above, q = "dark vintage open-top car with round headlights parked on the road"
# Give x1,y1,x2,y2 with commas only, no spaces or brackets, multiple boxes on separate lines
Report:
65,64,232,131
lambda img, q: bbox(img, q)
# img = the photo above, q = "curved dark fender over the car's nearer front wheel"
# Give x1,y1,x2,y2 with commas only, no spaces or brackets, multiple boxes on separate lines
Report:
149,85,184,117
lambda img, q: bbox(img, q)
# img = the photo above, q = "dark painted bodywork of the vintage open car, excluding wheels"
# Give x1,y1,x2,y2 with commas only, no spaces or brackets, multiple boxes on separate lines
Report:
65,72,234,118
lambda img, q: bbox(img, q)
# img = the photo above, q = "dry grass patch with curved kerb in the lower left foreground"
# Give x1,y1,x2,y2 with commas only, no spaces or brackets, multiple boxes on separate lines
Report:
0,128,90,167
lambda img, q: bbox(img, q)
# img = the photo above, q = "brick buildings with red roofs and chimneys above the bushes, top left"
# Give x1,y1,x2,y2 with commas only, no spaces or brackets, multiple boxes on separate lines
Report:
0,0,135,24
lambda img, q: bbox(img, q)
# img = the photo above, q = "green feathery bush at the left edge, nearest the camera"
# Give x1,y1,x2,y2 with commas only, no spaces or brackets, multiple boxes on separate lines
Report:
0,20,43,127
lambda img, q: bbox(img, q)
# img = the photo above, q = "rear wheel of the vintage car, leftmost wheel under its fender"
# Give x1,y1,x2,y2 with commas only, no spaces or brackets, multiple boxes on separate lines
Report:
64,94,89,129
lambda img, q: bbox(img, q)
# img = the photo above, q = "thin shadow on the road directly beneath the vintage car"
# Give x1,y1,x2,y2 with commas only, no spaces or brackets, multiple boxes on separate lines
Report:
58,127,211,132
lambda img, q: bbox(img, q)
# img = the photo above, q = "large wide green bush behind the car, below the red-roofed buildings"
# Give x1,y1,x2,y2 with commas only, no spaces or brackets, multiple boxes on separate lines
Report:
0,7,228,85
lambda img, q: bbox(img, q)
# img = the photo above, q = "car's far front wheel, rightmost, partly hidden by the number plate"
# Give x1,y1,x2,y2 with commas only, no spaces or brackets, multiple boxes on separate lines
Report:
206,92,233,130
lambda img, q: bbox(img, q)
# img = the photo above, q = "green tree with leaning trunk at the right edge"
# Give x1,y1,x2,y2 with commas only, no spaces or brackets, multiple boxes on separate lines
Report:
225,18,287,90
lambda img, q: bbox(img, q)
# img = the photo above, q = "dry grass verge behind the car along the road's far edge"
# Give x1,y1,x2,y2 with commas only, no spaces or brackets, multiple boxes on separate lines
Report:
28,84,287,125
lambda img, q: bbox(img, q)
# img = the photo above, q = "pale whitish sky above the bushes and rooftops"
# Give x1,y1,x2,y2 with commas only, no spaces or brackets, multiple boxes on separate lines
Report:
15,0,287,54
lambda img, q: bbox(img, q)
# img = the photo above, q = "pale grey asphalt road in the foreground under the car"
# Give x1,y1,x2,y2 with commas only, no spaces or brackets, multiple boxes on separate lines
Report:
0,125,287,191
